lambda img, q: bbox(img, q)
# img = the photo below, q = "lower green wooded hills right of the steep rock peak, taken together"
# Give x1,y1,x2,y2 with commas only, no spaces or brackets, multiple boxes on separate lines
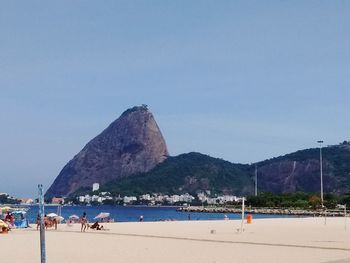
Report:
73,142,350,198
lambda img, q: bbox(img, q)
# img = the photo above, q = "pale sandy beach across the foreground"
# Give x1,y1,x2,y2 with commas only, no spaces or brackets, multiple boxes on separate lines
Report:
0,218,350,263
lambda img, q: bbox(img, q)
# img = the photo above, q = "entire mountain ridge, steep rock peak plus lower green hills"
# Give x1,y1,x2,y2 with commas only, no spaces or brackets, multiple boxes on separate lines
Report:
45,105,350,198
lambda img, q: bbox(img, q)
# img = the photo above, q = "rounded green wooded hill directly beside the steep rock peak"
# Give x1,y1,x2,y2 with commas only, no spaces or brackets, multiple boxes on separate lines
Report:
102,152,254,195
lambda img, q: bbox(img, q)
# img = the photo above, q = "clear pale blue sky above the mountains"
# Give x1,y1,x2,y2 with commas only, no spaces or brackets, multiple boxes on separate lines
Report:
0,0,350,197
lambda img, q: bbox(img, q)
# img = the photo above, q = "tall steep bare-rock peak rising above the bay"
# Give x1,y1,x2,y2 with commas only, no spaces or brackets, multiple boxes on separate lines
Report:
45,105,168,198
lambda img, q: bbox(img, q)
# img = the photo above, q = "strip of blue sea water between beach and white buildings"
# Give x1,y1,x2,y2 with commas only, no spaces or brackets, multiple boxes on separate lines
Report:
26,206,290,223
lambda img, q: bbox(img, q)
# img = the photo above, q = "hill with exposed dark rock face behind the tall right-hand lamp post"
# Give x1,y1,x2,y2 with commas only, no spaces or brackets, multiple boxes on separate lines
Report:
252,143,350,194
